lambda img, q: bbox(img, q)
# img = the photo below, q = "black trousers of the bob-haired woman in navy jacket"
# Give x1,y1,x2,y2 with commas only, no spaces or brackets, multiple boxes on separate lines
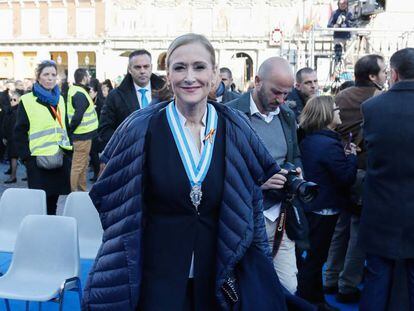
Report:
297,213,338,303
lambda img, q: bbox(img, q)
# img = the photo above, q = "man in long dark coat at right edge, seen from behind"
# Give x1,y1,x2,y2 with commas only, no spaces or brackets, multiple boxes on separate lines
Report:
359,48,414,311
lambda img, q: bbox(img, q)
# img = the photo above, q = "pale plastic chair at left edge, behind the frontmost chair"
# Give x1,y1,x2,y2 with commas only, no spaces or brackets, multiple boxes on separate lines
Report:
0,188,46,253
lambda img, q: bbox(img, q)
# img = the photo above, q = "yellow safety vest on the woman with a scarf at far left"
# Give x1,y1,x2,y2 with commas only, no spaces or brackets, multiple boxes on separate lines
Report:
20,92,72,156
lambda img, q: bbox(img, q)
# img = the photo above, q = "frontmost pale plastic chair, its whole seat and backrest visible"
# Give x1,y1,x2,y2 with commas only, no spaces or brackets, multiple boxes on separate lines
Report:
0,215,82,311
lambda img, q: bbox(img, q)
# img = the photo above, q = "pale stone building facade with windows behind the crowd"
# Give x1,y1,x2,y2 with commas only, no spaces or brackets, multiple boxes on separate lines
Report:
0,0,414,88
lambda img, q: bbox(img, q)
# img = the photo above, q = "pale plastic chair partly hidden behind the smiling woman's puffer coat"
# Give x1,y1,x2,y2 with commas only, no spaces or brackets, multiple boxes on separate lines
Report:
63,192,103,259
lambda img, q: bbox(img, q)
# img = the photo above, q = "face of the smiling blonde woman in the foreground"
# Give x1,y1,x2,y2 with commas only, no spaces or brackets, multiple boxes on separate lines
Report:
167,43,215,105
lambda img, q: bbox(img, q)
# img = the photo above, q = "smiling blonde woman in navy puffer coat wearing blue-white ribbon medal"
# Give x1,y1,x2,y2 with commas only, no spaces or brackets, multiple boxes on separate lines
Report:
83,34,285,311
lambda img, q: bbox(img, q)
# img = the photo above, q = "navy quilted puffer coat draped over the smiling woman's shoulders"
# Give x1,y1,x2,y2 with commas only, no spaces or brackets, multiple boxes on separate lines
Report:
82,102,285,311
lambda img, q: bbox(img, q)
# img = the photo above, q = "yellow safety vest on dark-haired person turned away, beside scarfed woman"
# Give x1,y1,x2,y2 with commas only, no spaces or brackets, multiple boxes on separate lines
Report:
67,85,98,134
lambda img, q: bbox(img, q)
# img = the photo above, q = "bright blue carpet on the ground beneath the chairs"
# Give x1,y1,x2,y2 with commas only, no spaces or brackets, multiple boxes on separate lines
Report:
0,253,358,311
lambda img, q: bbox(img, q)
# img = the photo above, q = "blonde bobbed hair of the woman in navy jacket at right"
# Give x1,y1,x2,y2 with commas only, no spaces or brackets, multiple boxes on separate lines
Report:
299,95,335,132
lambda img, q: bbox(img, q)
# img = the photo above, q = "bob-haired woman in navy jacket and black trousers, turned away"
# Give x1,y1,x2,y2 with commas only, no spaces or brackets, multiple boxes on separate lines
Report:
298,96,357,310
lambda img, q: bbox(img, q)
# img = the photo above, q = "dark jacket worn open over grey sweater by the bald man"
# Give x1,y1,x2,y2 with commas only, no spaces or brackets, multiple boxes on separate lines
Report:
227,92,302,171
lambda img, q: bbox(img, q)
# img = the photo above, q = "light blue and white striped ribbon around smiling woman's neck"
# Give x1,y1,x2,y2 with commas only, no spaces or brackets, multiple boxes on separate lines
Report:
166,101,218,187
